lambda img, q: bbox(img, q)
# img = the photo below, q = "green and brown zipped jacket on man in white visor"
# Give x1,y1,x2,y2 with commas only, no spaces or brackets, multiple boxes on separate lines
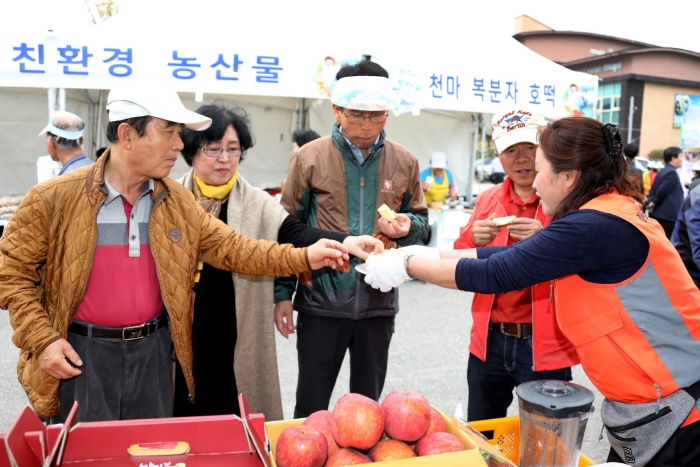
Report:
275,127,428,319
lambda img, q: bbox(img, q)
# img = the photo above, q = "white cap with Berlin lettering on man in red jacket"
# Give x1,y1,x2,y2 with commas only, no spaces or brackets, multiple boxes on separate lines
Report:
491,108,547,153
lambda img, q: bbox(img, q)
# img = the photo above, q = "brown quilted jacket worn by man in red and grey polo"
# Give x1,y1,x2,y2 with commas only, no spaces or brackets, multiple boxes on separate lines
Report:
0,153,309,418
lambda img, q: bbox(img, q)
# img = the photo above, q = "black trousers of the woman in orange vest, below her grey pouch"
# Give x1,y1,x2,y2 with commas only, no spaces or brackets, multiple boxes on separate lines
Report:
607,422,700,467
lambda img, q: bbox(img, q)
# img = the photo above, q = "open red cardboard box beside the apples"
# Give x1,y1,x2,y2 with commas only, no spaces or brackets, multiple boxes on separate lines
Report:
0,395,269,467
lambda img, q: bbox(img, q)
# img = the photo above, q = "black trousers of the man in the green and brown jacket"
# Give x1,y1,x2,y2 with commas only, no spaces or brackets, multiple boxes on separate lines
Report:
294,313,394,418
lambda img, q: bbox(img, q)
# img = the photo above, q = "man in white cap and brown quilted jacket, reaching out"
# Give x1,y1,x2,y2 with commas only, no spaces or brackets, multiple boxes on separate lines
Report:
0,88,348,422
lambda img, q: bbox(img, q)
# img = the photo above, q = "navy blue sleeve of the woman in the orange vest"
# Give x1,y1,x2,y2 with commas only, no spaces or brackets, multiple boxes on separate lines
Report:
455,209,649,294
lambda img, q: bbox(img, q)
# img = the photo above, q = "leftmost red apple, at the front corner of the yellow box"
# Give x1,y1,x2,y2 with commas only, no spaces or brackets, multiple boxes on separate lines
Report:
275,425,328,467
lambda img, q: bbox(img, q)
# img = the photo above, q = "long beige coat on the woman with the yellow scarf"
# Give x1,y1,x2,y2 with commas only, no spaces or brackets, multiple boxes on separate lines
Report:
178,170,288,420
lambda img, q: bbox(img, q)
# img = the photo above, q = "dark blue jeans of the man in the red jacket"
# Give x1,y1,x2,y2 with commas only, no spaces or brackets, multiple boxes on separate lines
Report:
467,323,571,421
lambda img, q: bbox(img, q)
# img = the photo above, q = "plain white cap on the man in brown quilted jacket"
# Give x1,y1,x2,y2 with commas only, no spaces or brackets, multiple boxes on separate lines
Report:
107,87,211,131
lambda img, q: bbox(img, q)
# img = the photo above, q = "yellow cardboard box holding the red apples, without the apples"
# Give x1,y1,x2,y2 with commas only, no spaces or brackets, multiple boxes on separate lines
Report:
265,408,504,467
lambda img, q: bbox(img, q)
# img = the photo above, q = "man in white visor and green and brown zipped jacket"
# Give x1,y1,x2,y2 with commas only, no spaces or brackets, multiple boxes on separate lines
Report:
275,60,428,418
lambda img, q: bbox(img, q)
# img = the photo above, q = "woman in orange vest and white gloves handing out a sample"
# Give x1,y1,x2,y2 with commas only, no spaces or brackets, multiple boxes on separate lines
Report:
365,118,700,467
